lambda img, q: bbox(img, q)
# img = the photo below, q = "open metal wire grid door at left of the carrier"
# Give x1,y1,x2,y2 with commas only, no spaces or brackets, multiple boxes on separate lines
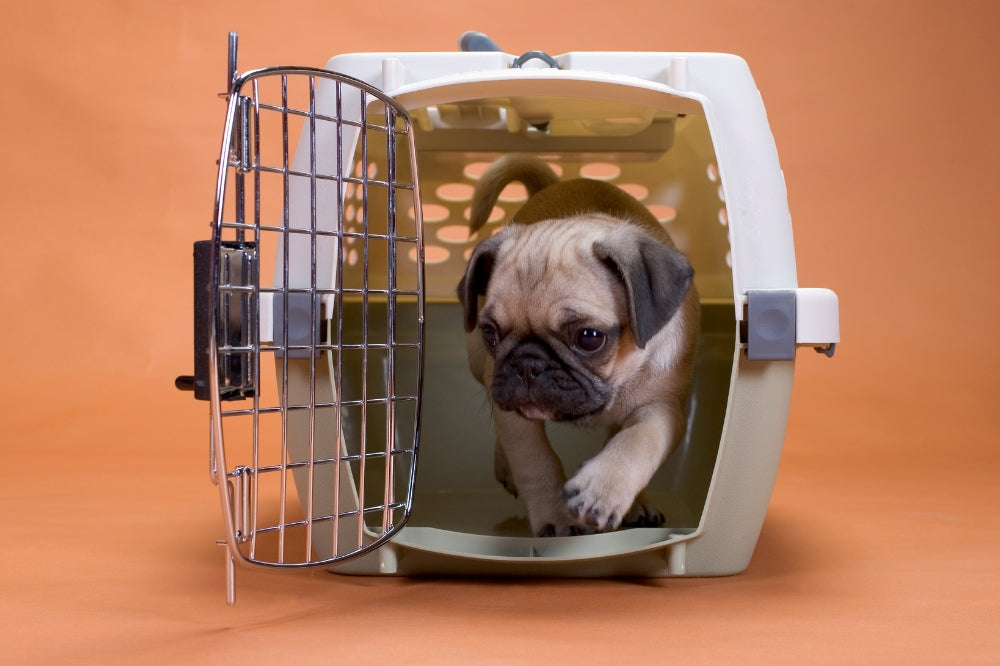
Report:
209,68,424,566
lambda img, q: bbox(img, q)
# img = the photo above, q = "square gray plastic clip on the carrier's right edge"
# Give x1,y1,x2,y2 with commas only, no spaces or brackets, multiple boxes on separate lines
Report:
746,289,795,361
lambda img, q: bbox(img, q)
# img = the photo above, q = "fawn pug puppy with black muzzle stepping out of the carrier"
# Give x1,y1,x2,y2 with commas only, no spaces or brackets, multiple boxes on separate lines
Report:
458,155,699,536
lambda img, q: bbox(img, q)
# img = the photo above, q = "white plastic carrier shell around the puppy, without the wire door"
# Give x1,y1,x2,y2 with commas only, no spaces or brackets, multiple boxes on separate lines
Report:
215,53,838,576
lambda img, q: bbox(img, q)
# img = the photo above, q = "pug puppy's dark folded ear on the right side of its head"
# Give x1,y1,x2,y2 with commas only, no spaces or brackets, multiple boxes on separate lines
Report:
594,234,694,348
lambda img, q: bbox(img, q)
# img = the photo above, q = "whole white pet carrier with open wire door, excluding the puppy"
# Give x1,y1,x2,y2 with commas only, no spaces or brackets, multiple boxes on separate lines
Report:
178,35,839,602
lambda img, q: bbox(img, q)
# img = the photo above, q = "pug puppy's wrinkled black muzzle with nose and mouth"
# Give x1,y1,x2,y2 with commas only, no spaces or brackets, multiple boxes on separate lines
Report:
491,339,610,421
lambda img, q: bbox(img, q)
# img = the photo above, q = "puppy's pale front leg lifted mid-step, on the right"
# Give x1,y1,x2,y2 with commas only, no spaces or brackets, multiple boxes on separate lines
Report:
565,404,684,531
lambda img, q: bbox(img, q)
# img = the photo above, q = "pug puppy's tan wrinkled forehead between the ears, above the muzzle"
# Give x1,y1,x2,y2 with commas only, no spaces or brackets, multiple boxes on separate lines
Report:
483,217,627,332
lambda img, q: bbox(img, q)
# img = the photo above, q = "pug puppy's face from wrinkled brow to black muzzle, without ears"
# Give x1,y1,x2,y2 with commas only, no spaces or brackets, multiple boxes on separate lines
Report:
477,239,634,421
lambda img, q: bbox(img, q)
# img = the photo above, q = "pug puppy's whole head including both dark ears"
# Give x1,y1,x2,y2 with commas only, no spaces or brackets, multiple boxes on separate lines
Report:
459,215,690,421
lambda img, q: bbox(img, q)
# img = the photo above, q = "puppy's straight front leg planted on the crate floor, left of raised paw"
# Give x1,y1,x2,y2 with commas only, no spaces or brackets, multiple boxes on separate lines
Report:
493,407,579,536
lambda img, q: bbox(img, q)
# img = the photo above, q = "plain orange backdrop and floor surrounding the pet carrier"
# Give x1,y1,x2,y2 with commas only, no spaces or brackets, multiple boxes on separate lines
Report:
0,0,1000,664
